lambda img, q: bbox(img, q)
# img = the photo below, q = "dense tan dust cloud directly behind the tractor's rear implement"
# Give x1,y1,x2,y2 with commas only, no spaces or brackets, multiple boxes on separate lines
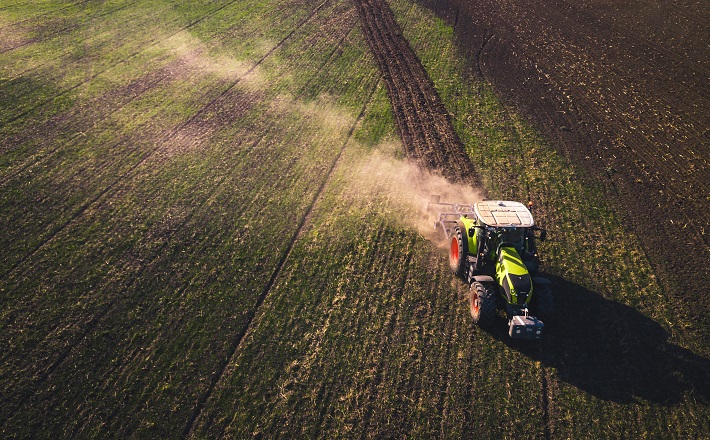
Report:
347,145,483,247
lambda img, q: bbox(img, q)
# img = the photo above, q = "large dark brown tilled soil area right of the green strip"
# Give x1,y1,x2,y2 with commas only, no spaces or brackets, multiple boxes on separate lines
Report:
412,0,710,327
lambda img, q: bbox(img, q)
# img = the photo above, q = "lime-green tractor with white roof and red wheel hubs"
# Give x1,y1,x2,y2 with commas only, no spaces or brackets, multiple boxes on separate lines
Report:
430,196,554,339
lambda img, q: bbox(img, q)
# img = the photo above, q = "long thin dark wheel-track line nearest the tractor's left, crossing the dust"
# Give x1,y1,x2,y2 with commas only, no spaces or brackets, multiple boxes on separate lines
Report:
182,77,380,438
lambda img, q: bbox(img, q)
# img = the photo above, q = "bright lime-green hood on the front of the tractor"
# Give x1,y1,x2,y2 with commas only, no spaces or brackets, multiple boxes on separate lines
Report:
496,243,532,305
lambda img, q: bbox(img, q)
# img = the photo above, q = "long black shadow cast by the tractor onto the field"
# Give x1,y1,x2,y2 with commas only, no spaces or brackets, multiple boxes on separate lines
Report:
486,276,710,405
